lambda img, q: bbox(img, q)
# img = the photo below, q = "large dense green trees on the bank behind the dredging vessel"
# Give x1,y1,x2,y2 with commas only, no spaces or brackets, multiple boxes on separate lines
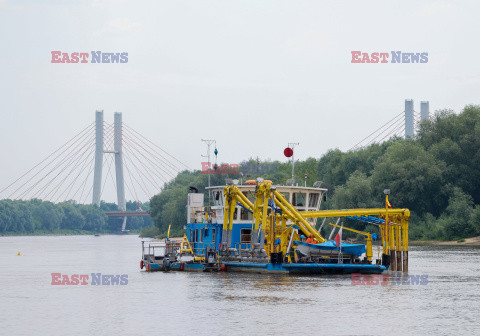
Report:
150,106,480,240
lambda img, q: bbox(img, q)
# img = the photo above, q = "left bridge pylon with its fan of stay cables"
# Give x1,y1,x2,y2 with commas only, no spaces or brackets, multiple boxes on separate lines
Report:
0,111,190,230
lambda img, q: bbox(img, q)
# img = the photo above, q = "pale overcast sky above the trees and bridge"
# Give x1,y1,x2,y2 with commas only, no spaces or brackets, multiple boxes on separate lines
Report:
0,0,480,202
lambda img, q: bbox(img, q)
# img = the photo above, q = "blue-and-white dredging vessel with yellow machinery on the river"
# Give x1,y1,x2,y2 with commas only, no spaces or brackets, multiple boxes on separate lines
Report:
141,178,410,274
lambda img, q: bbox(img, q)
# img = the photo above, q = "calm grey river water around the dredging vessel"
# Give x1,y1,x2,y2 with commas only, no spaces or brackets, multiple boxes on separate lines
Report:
0,235,480,335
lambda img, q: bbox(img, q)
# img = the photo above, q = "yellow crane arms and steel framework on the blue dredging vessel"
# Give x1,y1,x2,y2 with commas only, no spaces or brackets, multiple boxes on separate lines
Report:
221,179,410,271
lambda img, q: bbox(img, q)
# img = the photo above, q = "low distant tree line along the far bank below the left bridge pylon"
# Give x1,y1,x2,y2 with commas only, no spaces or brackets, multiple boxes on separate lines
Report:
0,199,152,234
